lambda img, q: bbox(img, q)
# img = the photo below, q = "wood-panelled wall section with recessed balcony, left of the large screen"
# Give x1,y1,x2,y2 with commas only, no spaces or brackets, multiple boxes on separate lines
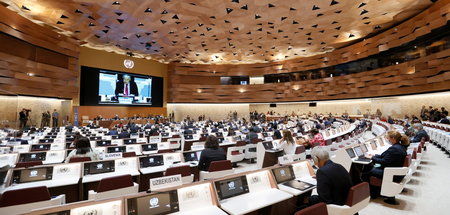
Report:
0,6,79,99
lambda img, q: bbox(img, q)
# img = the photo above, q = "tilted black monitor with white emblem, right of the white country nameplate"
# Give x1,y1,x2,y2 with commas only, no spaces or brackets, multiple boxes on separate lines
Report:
214,175,249,200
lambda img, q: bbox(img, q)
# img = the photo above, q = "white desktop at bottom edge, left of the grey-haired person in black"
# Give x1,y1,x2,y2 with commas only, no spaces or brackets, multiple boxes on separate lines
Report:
220,188,292,215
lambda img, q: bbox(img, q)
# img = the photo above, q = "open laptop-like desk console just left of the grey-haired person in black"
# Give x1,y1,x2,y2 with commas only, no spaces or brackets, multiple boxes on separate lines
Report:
272,166,316,191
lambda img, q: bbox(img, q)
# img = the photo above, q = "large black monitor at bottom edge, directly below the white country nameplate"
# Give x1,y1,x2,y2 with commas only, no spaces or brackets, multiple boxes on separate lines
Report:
127,190,179,215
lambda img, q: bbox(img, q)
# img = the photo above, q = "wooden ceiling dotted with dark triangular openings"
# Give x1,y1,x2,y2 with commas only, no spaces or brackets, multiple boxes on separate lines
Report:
0,0,435,64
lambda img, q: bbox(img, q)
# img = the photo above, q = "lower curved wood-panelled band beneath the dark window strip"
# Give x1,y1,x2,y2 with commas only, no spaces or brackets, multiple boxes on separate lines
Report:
170,49,450,103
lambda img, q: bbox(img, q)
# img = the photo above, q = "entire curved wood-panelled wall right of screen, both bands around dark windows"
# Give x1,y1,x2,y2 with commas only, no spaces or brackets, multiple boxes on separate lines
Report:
169,0,450,103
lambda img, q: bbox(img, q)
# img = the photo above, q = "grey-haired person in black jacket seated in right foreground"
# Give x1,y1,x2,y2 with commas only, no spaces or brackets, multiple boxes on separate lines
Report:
305,146,352,206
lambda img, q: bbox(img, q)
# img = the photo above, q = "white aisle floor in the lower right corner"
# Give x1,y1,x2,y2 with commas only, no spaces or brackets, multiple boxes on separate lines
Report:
359,145,450,215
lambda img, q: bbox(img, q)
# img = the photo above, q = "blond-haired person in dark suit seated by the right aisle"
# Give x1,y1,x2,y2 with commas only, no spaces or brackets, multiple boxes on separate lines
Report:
362,131,409,197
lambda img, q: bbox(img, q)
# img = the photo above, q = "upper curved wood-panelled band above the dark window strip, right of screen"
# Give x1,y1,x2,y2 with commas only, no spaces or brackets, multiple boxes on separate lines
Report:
171,0,450,76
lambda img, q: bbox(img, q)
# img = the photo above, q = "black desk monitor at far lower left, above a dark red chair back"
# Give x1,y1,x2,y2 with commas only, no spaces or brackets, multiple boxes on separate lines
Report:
13,167,53,183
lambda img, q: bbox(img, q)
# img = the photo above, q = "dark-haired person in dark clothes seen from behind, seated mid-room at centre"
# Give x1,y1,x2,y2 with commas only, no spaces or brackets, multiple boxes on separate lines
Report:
198,135,227,171
